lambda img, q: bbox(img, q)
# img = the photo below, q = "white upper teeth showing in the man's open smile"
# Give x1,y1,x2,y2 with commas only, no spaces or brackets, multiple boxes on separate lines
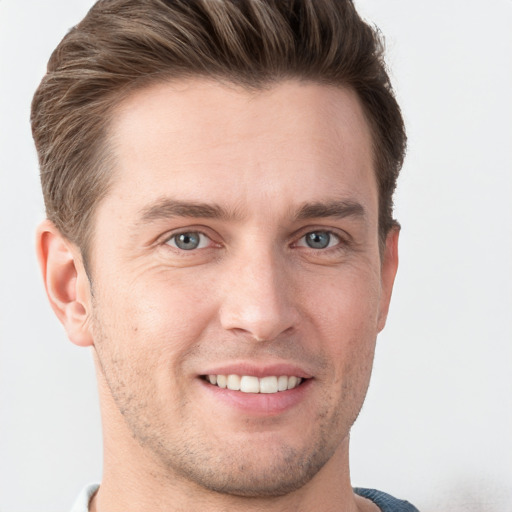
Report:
201,375,305,394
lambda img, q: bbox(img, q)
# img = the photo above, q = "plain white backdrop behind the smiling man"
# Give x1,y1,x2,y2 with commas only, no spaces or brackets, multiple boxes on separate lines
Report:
0,0,512,512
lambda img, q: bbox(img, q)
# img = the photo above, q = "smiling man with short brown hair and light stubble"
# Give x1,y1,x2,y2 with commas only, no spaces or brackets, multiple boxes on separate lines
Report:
32,0,416,512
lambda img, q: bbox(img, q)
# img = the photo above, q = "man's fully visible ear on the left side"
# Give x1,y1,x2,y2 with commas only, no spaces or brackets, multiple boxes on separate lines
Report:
36,220,93,347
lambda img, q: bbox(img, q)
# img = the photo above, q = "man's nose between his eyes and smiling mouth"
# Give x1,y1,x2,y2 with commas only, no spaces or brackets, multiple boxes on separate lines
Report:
220,246,300,341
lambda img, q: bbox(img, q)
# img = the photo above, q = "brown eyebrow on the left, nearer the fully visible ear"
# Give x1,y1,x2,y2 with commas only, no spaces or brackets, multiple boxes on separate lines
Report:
140,198,239,224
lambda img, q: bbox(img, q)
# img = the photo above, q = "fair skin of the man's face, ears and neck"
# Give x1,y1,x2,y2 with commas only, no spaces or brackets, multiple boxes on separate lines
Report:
38,79,398,512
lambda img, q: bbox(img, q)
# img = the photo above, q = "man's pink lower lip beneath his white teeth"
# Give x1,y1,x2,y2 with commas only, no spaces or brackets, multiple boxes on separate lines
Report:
198,379,313,416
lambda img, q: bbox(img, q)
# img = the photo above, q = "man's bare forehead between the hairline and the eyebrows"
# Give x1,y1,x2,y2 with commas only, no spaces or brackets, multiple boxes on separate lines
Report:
103,79,376,222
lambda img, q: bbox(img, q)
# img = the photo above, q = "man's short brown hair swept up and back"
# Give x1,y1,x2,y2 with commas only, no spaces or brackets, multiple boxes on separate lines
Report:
31,0,406,256
